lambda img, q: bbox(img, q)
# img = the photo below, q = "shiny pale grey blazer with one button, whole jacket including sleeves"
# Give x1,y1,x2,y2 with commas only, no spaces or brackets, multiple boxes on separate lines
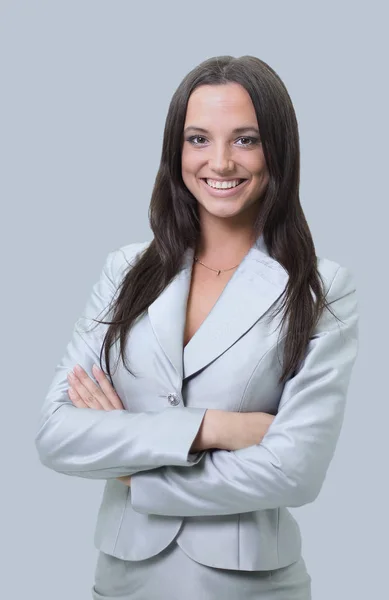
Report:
35,237,359,570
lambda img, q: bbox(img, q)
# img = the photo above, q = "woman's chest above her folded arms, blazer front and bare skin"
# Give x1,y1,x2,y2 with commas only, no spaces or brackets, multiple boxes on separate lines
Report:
112,256,283,412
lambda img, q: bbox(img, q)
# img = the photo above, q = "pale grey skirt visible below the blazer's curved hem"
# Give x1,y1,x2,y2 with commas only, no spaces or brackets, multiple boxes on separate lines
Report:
92,540,312,600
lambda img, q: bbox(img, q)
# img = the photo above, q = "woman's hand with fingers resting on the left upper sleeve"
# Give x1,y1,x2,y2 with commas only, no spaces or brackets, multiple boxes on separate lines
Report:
68,365,131,486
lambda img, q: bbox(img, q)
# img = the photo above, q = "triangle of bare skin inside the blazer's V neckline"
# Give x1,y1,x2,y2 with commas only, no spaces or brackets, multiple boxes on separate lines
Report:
184,264,236,346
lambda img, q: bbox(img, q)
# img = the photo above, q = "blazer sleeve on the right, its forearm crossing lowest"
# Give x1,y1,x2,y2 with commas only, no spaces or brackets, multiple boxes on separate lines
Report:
130,267,359,517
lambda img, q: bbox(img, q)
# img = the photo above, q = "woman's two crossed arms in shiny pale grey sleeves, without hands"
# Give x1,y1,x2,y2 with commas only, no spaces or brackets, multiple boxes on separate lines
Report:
35,248,358,516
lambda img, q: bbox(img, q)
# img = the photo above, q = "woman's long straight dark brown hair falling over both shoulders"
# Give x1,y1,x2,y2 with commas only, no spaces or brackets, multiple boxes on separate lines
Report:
90,56,333,383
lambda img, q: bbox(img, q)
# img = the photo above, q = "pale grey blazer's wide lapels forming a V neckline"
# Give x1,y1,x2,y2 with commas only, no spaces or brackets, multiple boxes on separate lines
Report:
148,235,289,379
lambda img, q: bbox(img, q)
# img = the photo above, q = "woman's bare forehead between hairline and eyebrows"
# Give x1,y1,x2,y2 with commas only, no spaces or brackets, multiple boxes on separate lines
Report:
185,83,257,126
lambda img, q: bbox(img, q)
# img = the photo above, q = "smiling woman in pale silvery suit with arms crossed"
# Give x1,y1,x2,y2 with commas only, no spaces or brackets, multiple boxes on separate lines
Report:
36,56,358,600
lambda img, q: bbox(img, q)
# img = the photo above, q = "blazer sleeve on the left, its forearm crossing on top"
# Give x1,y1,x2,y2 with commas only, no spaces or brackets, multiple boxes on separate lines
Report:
35,248,206,479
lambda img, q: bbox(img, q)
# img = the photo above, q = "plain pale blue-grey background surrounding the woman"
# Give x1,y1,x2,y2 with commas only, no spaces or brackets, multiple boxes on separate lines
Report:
0,0,389,600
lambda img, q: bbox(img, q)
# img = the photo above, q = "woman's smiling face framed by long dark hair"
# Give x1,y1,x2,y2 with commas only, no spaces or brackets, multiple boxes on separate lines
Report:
181,83,269,223
